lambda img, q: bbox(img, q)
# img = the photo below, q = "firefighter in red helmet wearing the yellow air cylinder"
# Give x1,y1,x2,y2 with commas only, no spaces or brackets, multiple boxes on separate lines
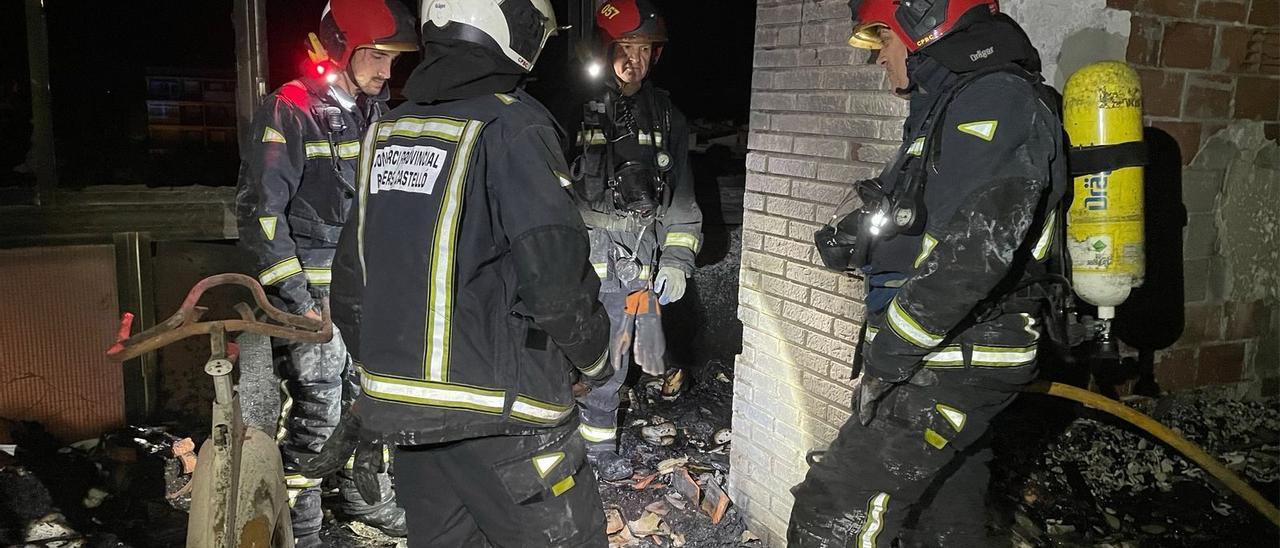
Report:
787,0,1070,547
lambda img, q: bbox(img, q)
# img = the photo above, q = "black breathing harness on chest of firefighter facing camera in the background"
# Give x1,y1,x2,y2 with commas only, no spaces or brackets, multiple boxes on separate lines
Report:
571,84,673,283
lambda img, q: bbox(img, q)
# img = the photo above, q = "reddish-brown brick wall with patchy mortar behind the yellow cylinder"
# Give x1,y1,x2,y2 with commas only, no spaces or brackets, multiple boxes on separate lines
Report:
1107,0,1280,393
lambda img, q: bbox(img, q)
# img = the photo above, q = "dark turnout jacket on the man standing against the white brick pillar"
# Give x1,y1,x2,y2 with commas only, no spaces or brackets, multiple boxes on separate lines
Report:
568,82,703,292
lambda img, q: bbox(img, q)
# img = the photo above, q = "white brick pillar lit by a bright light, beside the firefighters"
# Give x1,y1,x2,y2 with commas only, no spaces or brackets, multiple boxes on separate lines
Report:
730,0,906,547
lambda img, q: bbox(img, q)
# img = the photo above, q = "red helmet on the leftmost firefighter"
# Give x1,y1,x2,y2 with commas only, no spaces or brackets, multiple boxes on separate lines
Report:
311,0,417,69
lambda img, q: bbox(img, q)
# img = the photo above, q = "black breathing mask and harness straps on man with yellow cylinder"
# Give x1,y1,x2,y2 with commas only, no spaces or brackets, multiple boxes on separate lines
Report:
814,64,1073,347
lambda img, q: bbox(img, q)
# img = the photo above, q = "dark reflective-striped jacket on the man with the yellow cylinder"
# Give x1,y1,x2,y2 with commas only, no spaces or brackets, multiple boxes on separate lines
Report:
863,56,1070,384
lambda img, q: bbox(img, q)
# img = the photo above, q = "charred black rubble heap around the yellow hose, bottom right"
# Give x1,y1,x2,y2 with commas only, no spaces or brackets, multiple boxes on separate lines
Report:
996,393,1280,547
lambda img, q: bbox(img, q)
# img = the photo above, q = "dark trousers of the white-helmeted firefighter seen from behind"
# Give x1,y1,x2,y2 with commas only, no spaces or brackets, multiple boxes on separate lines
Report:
396,420,608,548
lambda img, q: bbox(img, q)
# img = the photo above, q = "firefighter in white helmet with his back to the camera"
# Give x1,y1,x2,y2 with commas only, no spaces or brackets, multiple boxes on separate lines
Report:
311,0,612,547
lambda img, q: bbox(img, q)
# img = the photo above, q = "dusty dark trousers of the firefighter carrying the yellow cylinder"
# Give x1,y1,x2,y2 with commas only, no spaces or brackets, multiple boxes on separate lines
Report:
787,364,1034,548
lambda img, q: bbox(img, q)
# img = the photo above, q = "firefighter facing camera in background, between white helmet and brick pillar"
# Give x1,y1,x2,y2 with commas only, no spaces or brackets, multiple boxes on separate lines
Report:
571,0,703,481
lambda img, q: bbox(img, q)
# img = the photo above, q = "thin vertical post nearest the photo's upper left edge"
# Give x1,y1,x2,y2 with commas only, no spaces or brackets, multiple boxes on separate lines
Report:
27,0,58,205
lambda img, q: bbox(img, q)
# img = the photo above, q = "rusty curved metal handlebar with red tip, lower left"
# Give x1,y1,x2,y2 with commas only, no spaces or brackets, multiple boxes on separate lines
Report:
106,274,333,361
